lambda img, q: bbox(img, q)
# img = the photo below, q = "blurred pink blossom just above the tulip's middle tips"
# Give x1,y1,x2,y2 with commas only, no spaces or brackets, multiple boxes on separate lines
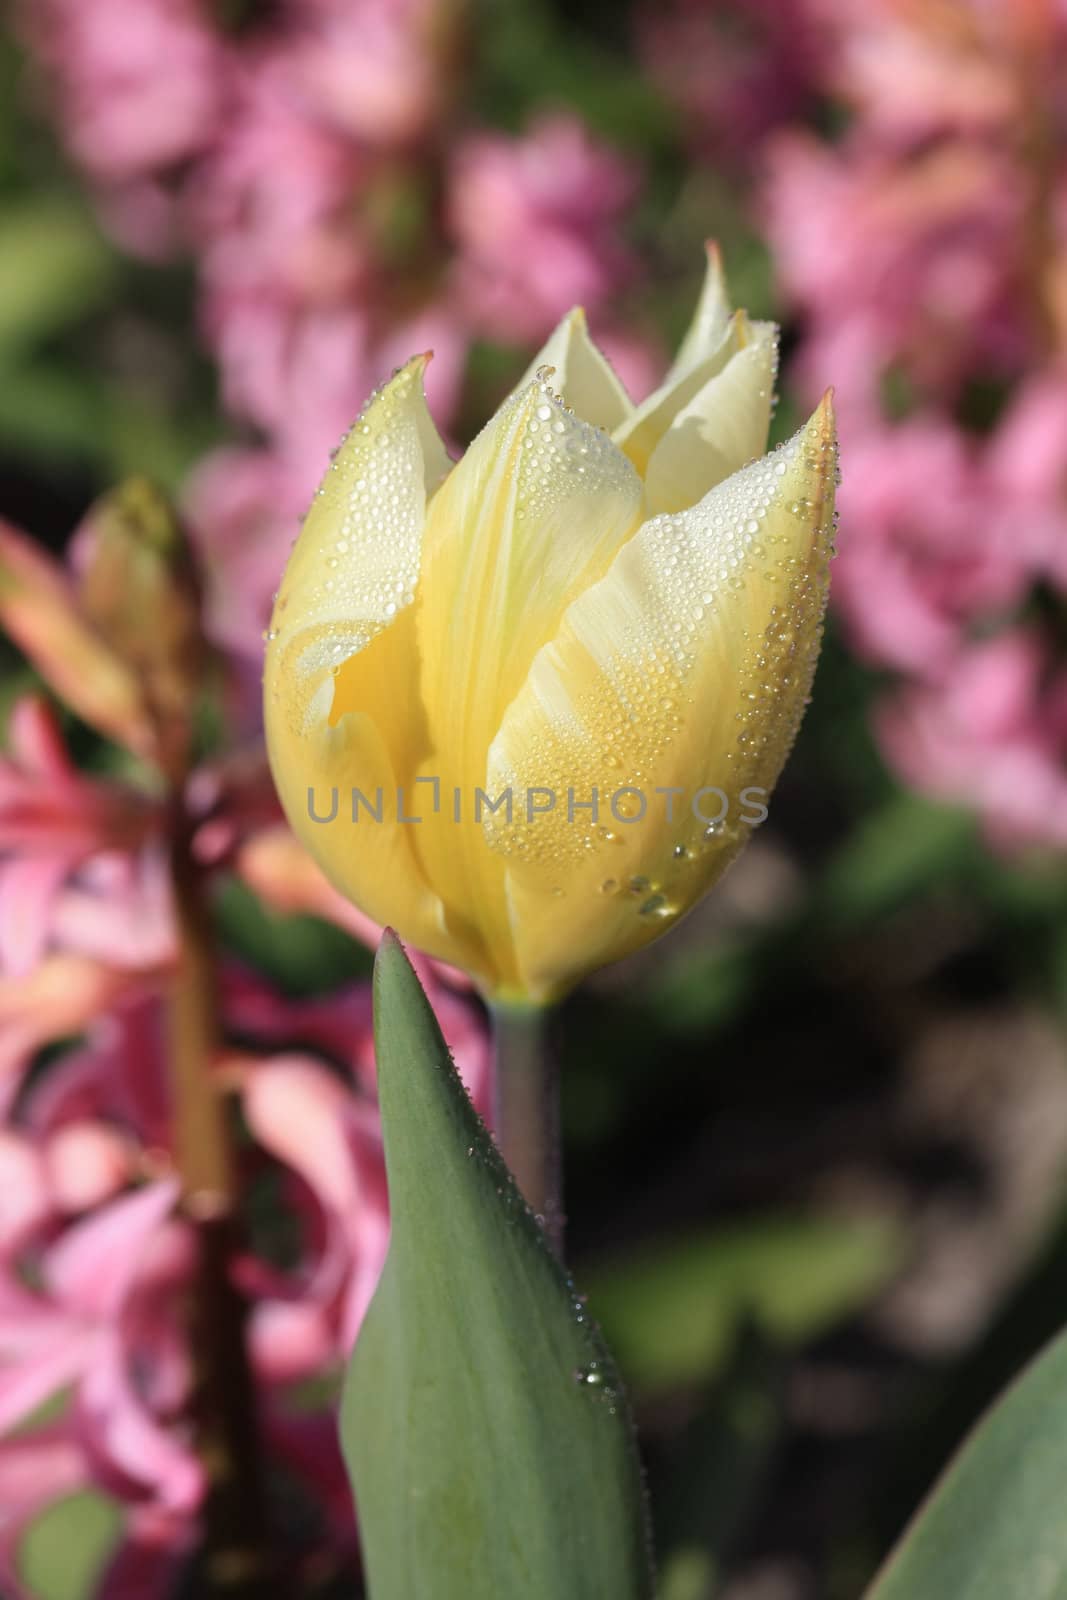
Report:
448,115,638,342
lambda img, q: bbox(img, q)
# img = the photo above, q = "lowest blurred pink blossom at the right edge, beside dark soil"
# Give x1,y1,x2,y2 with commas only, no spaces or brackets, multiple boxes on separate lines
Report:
878,629,1067,850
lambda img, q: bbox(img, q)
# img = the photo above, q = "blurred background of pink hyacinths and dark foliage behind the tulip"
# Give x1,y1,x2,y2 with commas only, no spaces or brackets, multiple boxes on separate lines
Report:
0,0,1067,1600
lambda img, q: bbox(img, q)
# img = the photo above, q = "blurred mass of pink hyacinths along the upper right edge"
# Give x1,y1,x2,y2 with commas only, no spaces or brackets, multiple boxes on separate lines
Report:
760,0,1067,848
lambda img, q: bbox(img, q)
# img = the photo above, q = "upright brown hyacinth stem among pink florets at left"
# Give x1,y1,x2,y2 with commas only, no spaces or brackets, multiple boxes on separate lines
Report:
168,805,275,1600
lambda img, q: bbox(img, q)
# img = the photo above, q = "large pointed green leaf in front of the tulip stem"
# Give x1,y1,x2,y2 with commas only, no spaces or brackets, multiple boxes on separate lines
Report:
341,934,653,1600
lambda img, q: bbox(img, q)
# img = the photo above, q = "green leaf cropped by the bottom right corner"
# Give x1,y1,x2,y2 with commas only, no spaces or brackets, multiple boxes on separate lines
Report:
867,1334,1067,1600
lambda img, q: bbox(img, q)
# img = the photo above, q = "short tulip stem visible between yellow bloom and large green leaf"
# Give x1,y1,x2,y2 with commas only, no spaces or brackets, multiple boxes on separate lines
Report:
493,1005,565,1256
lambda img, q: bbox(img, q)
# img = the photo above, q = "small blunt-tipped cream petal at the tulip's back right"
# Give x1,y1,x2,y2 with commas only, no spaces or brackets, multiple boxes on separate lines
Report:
645,322,777,517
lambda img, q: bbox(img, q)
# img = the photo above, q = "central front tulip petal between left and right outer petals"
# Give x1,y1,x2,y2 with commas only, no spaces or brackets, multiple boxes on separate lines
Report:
409,382,643,968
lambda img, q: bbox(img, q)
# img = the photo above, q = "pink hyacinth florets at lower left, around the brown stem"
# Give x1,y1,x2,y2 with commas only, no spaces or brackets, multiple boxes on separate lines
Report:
0,963,490,1592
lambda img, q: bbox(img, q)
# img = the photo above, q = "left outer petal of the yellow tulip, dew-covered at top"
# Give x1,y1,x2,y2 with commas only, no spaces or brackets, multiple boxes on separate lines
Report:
264,357,478,966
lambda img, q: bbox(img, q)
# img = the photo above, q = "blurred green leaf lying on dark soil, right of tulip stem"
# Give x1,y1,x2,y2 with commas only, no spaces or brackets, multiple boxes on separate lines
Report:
589,1216,901,1390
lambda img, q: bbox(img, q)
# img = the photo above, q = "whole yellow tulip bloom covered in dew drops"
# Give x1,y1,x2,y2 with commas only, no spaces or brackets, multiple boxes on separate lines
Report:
266,250,835,1003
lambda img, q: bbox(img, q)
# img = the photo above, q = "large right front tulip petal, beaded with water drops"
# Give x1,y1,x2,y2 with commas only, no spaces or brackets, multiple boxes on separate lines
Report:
485,397,837,998
